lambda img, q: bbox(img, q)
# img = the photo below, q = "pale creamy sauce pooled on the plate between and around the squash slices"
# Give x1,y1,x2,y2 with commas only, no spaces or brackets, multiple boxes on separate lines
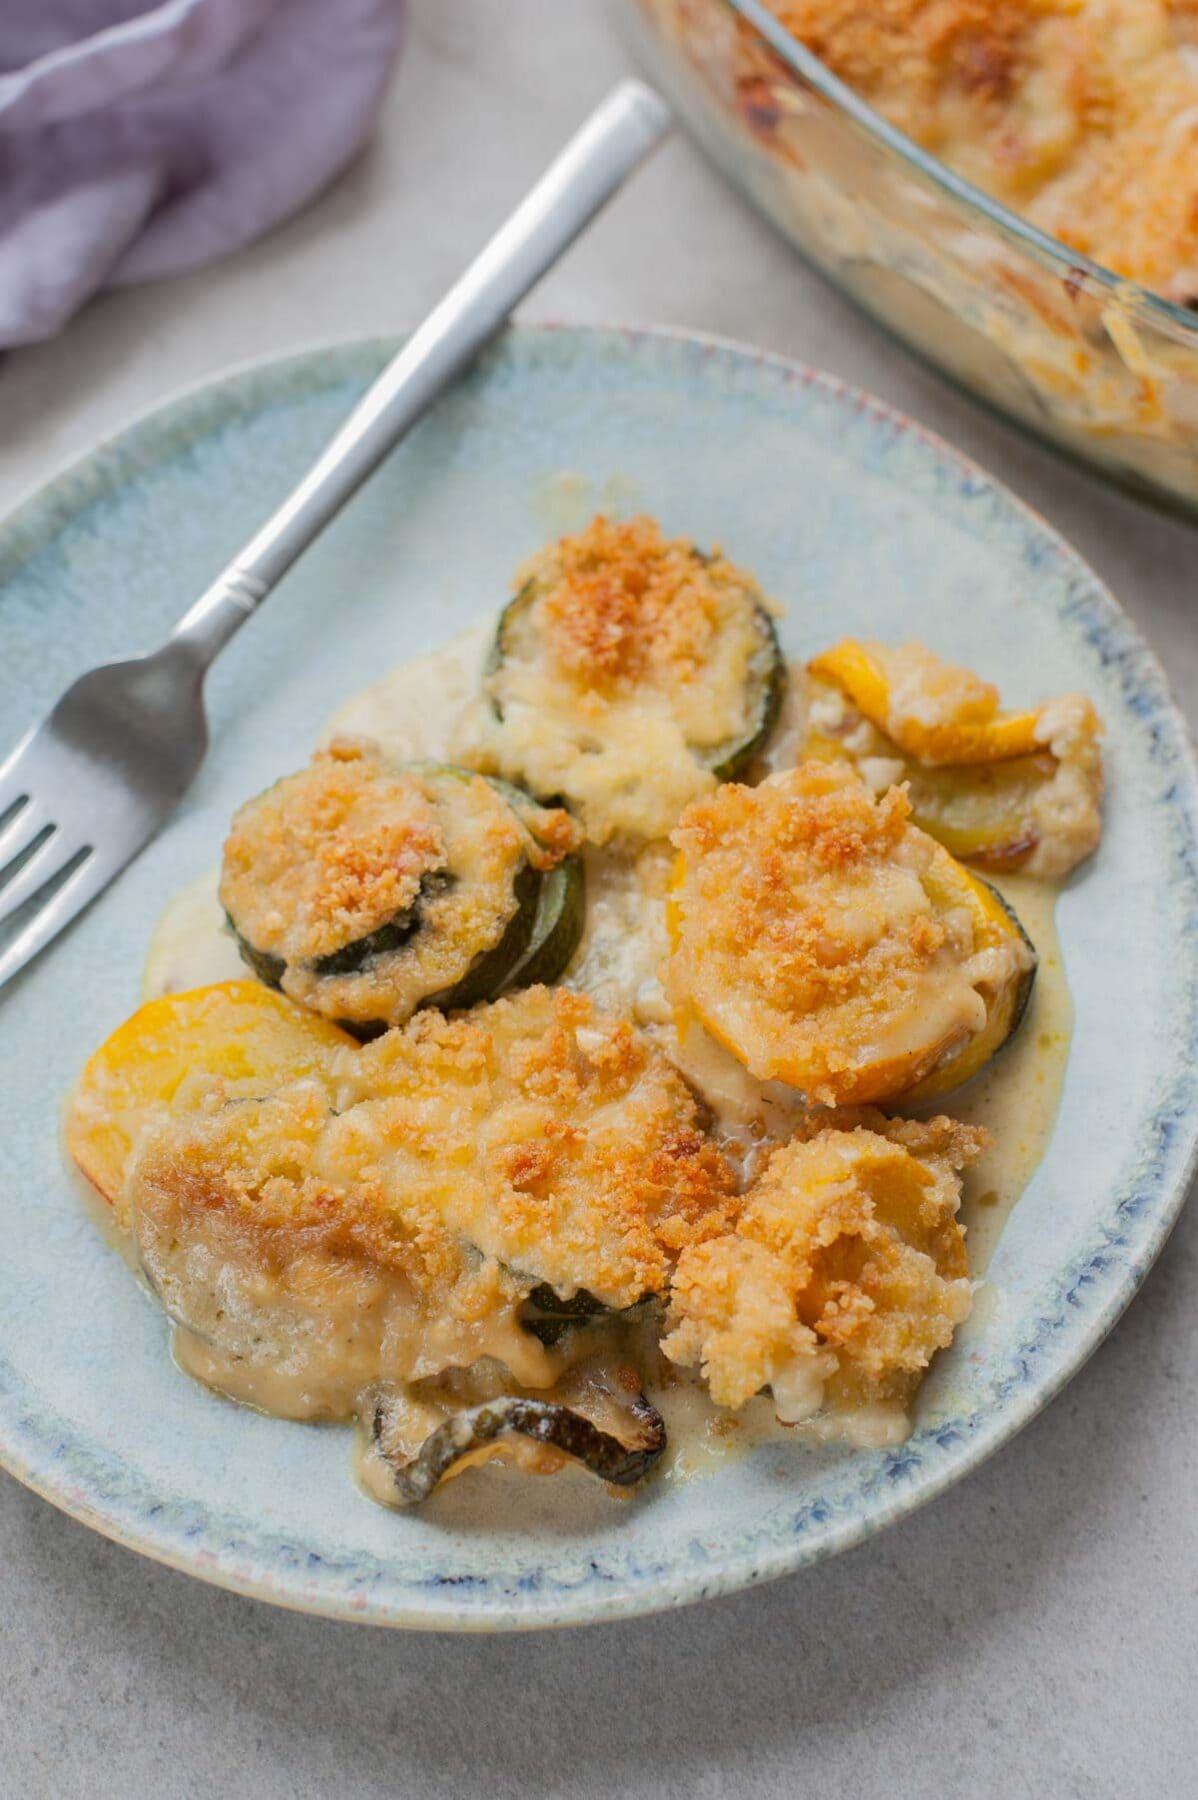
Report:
144,626,1072,1481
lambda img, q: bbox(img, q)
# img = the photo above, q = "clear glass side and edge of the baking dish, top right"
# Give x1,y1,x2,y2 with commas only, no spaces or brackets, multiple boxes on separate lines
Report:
622,0,1198,517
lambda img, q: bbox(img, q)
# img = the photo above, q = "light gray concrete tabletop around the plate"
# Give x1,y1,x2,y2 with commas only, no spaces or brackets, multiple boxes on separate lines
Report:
0,0,1198,1800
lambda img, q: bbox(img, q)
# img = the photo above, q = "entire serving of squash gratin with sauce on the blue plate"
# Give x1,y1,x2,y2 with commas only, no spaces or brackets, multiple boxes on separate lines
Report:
67,518,1101,1507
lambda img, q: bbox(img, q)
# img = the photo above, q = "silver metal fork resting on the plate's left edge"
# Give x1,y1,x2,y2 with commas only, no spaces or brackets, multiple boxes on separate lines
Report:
0,81,669,986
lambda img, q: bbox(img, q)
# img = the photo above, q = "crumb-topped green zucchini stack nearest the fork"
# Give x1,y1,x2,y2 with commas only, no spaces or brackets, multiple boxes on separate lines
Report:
221,743,585,1037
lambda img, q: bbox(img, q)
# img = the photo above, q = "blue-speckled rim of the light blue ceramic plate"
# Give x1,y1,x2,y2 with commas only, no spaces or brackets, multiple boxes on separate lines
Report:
0,324,1198,1631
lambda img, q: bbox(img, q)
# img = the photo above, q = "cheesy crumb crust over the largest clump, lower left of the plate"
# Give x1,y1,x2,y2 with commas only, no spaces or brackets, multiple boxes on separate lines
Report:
117,988,739,1417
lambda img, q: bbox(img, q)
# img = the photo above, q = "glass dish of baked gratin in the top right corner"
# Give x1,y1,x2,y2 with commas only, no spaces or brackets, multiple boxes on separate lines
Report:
631,0,1198,513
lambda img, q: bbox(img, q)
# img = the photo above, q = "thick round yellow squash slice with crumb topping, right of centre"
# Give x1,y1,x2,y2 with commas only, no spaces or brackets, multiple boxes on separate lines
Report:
667,761,1036,1105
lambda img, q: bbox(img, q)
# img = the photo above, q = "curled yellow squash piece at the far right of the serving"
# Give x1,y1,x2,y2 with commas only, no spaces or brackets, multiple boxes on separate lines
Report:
806,639,1103,878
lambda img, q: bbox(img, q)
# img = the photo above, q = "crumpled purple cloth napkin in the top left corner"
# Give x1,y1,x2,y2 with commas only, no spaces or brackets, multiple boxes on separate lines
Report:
0,0,405,349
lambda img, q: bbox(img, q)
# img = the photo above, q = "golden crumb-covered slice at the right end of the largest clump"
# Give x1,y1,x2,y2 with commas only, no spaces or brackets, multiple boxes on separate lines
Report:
338,988,738,1307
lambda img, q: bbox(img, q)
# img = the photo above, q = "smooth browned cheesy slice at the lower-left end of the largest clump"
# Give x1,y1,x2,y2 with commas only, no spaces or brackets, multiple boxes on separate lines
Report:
126,1082,552,1418
